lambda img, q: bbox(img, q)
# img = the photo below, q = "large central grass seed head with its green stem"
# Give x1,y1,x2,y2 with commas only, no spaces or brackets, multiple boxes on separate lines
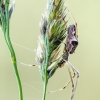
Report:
36,0,67,100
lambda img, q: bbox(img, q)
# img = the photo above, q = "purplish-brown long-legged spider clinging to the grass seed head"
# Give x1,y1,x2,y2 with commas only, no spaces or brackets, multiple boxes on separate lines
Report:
48,10,79,100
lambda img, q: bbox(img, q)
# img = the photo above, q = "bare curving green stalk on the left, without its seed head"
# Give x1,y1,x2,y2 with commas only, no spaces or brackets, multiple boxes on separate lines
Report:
3,0,23,100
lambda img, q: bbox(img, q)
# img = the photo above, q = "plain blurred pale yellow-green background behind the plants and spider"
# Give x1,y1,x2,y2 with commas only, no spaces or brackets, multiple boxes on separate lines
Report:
0,0,100,100
